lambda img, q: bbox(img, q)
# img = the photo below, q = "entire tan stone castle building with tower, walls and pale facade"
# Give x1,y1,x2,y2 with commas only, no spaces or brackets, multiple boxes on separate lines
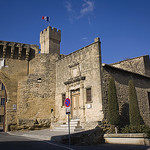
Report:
0,26,150,131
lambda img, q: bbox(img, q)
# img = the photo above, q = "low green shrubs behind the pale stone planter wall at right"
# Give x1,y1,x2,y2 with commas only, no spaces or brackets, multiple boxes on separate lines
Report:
121,125,150,138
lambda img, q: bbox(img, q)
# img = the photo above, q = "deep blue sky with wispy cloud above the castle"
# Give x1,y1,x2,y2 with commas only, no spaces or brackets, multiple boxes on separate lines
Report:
0,0,150,63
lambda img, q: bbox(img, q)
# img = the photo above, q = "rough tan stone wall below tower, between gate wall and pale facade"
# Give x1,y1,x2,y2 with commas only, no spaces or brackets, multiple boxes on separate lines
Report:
18,54,58,128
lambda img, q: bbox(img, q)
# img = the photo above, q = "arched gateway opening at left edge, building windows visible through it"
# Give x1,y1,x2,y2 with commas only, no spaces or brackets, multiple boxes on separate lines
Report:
0,81,7,131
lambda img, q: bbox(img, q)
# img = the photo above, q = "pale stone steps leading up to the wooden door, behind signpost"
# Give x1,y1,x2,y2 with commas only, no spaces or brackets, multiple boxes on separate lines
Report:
52,119,84,133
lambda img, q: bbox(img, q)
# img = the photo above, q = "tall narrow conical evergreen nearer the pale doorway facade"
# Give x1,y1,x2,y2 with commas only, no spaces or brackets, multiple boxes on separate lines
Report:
108,78,119,126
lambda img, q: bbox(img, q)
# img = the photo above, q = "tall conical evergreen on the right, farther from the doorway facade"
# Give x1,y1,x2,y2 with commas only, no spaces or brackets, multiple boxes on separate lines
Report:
128,80,141,126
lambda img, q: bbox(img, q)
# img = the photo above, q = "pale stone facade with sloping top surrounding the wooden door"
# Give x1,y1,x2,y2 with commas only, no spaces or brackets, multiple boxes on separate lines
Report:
55,38,103,128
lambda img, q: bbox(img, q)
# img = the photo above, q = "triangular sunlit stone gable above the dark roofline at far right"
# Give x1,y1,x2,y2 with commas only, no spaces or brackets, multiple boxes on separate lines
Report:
111,55,150,76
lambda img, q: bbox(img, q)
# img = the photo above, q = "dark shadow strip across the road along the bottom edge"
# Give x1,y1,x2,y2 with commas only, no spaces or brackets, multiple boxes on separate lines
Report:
0,140,150,150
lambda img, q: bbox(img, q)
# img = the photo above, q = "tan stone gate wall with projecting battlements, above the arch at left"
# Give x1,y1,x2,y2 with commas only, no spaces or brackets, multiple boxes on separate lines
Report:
0,41,39,131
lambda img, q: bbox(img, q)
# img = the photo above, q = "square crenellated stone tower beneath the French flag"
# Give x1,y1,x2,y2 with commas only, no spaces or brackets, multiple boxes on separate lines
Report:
40,26,61,54
